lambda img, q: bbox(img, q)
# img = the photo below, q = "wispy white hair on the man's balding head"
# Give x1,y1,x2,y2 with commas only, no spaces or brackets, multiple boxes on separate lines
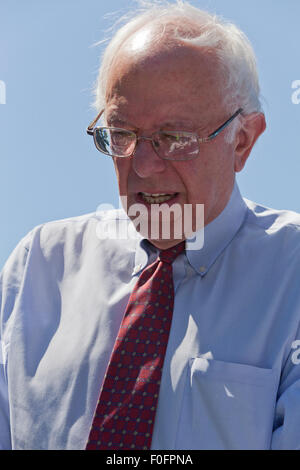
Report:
94,0,262,140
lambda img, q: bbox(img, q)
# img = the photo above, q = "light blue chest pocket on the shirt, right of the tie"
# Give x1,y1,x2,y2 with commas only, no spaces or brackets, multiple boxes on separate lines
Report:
175,357,279,450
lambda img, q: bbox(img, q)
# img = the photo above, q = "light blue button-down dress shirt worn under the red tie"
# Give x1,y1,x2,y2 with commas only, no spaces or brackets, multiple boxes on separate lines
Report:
0,185,300,449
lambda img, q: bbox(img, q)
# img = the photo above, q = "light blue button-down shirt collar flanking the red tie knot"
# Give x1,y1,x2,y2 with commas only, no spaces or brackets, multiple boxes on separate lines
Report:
132,182,247,276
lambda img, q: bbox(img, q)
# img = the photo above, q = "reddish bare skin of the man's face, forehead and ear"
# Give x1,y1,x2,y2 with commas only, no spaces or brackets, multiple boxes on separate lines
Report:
105,23,266,249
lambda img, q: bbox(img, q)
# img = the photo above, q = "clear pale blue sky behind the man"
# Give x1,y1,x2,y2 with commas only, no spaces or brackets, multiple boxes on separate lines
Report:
0,0,300,269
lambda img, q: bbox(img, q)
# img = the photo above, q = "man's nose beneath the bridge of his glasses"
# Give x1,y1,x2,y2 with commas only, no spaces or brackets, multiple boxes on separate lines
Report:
132,137,167,178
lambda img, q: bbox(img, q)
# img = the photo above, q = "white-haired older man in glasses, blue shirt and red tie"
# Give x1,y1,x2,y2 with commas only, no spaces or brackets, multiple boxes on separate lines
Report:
0,2,300,450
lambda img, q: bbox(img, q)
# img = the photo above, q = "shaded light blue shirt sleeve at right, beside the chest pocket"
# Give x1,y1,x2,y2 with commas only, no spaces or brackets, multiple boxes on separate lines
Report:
271,322,300,450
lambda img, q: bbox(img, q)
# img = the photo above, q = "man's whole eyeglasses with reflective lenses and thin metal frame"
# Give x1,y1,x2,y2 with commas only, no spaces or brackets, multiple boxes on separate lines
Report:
87,108,243,161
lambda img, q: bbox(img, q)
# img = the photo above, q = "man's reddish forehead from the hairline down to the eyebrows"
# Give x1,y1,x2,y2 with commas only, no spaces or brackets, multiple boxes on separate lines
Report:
106,44,222,127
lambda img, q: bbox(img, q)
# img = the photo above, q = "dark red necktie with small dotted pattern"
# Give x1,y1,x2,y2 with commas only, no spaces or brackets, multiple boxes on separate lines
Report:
86,242,185,450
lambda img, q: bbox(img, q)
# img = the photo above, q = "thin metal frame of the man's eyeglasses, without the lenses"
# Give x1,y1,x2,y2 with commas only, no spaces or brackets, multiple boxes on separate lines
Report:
86,108,243,161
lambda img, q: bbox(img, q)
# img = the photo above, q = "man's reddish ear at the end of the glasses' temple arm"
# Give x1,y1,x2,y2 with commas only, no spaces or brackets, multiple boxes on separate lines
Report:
234,113,266,173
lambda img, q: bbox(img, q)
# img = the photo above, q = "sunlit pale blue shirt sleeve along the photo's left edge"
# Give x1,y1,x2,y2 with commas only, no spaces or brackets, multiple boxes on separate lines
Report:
0,232,31,450
